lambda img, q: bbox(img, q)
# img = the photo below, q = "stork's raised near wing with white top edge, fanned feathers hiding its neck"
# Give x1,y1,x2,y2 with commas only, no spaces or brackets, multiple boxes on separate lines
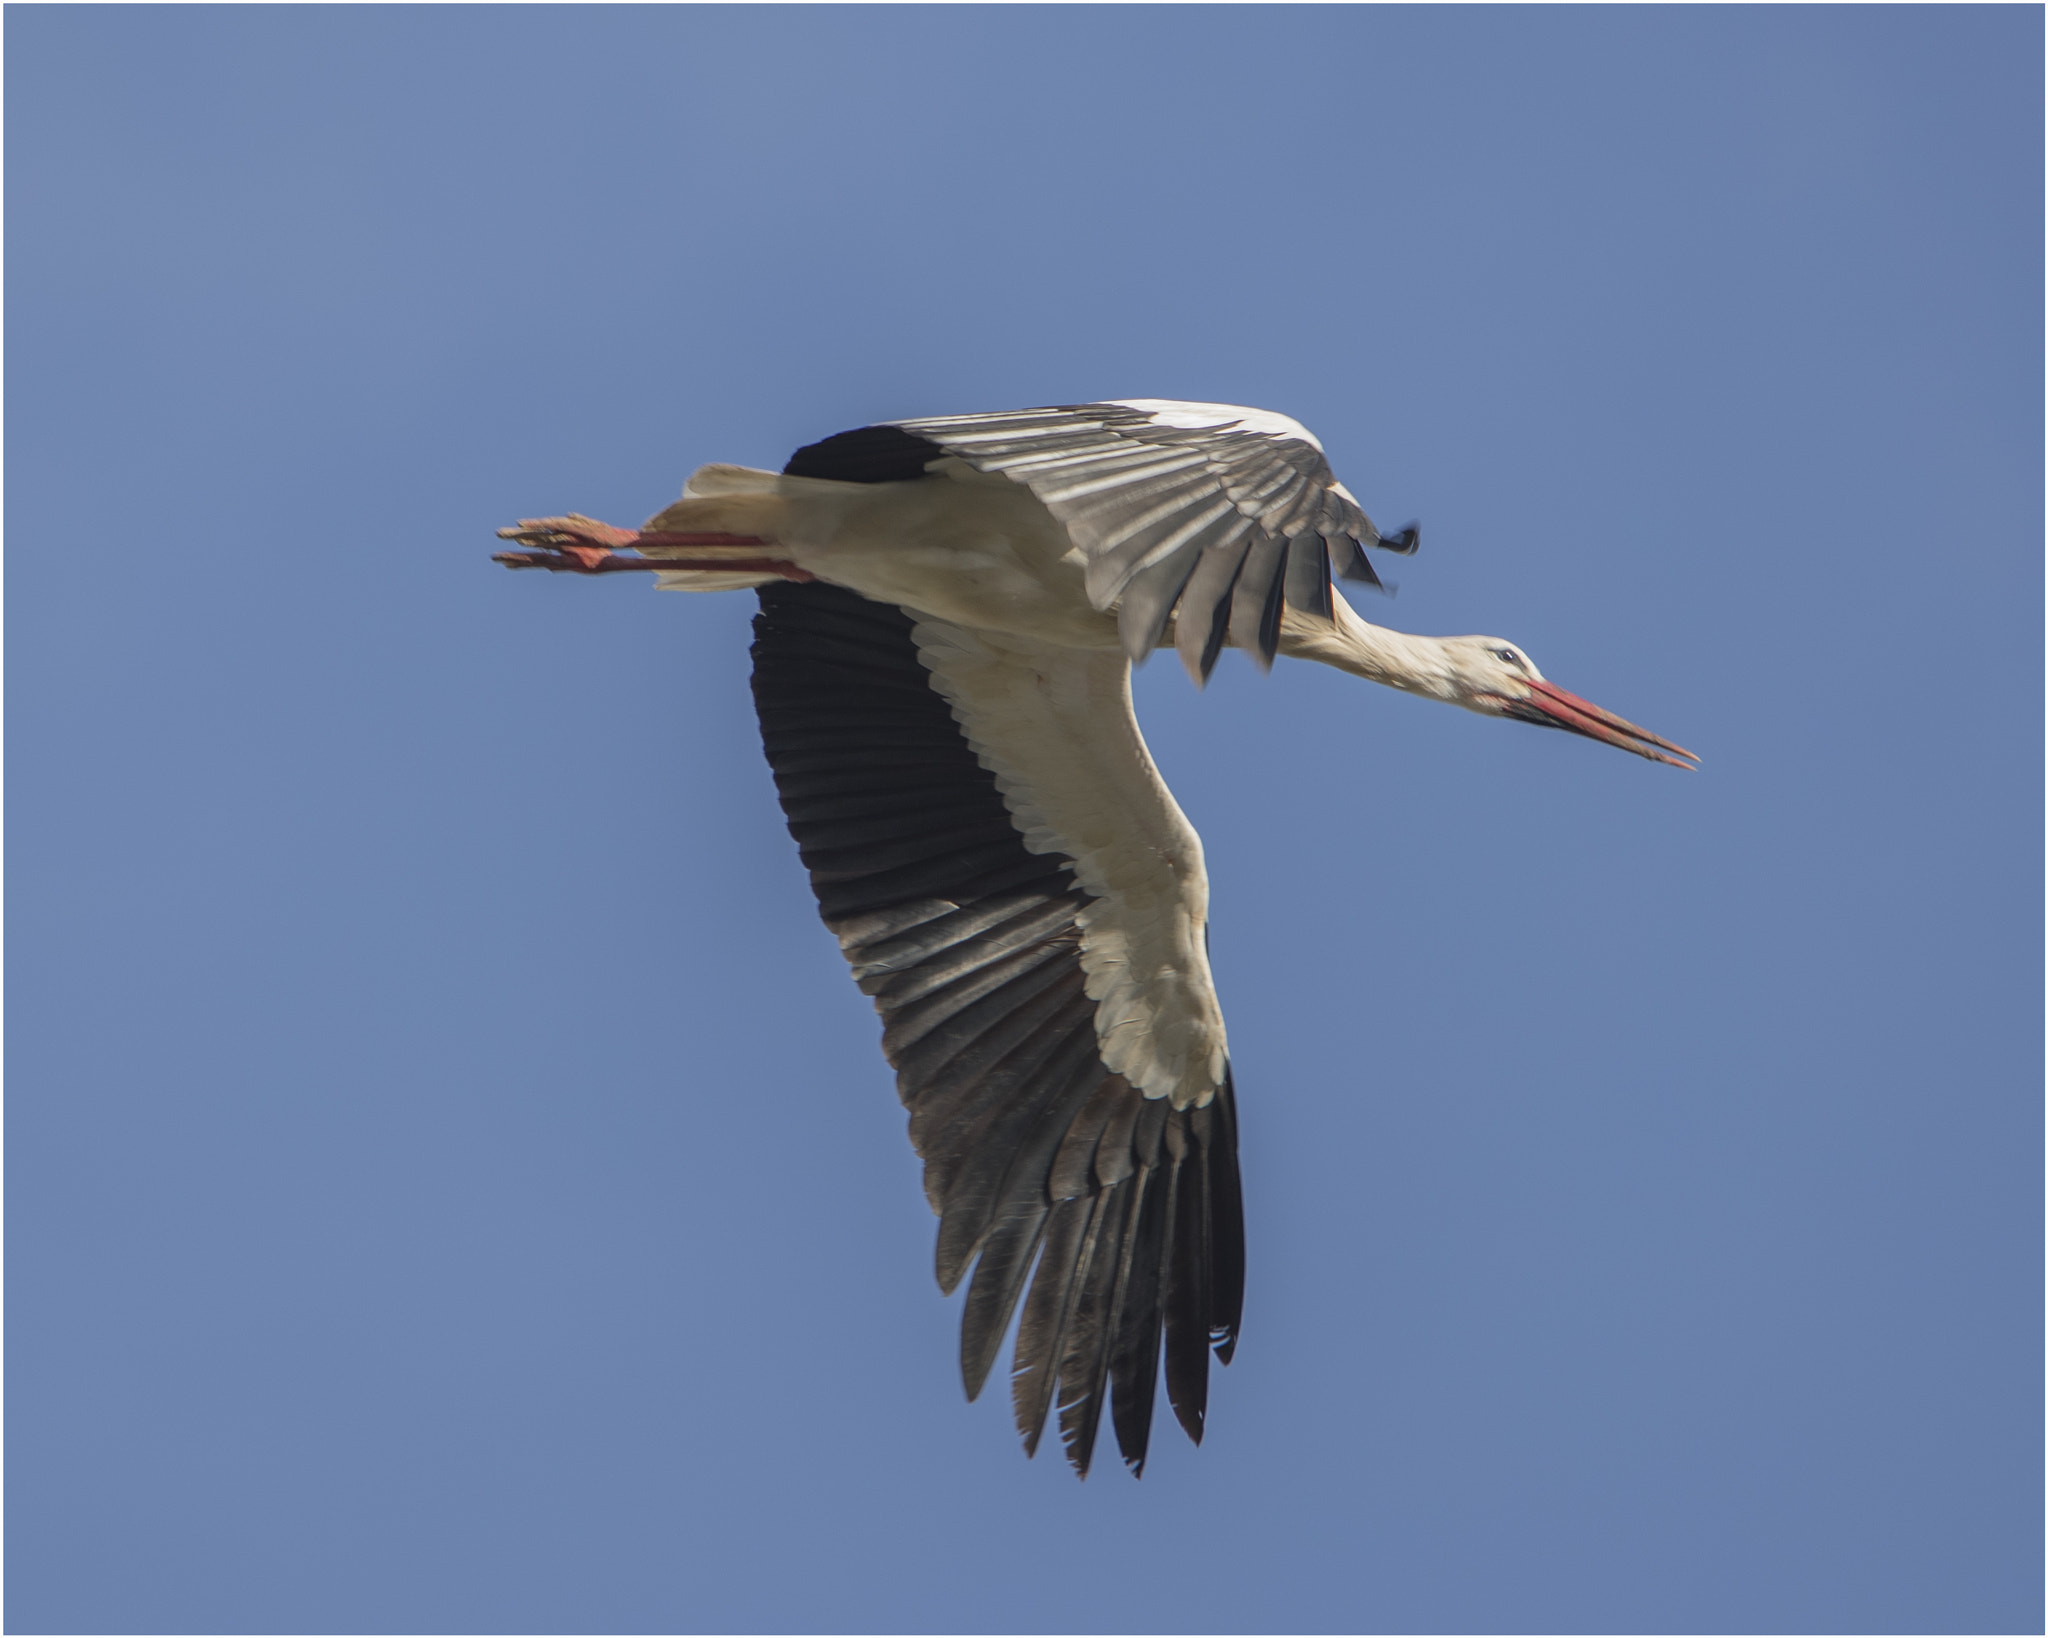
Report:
888,399,1417,678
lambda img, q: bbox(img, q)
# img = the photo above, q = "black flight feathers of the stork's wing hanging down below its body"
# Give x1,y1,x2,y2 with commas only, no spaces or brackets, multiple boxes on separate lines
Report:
754,577,1243,1472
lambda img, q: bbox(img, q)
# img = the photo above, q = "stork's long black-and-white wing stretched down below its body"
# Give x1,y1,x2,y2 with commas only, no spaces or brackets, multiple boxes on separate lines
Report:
754,584,1243,1474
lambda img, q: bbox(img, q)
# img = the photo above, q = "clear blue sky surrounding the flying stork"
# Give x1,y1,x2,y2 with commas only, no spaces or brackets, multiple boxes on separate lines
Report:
8,6,2042,1632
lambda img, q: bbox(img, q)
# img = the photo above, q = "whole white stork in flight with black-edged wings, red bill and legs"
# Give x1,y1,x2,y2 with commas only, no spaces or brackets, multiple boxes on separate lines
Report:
498,399,1694,1476
